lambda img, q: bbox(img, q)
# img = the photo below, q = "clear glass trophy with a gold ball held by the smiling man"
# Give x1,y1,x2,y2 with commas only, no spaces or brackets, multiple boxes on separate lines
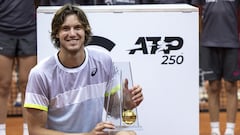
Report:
105,62,142,131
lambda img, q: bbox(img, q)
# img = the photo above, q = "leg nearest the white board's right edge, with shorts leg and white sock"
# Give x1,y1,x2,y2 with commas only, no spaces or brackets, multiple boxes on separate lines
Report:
200,46,222,135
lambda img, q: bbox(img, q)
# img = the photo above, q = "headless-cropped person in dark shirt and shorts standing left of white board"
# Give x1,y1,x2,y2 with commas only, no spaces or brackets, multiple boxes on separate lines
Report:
0,0,37,135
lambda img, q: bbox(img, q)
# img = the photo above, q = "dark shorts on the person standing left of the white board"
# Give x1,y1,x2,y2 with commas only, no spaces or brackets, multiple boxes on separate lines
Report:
0,31,37,57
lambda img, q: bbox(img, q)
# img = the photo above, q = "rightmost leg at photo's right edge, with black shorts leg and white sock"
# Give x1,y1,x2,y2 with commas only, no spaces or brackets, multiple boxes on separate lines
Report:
222,48,240,135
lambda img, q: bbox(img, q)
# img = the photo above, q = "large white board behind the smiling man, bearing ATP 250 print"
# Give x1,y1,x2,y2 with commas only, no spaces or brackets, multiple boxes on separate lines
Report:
37,4,199,135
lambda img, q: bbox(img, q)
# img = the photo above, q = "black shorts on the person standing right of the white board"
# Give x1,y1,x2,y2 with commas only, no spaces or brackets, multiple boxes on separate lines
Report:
200,46,240,81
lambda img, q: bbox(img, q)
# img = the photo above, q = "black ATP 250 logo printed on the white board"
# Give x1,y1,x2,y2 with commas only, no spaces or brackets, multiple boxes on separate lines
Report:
128,37,184,65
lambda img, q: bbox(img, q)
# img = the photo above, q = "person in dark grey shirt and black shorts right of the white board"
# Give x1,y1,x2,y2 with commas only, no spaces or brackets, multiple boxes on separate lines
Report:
192,0,240,135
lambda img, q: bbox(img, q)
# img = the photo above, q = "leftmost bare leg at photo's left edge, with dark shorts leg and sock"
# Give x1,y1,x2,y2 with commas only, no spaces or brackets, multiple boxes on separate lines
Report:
0,31,17,135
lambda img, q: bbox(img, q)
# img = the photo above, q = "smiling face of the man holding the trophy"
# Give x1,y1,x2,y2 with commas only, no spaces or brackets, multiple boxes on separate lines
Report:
57,14,85,53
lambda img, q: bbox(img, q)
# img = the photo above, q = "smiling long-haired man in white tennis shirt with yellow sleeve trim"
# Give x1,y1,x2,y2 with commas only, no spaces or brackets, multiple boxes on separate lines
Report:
24,4,143,135
